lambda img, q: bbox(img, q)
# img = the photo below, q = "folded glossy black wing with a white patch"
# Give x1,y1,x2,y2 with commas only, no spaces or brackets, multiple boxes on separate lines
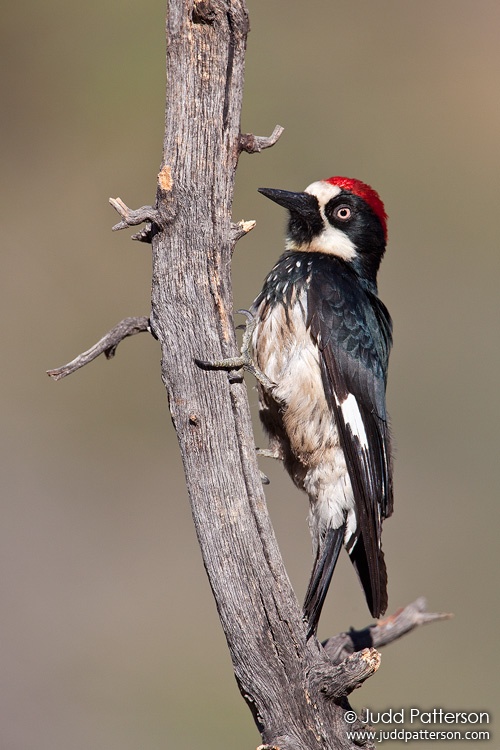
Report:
308,258,393,617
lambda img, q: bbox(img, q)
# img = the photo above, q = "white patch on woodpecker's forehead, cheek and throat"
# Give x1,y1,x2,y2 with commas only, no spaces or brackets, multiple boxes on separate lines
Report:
286,180,357,260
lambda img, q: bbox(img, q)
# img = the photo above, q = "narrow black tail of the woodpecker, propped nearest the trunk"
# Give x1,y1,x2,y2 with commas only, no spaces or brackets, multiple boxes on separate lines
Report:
303,524,345,638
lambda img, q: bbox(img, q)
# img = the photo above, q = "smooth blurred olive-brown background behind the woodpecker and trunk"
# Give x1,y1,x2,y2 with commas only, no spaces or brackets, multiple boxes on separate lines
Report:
0,0,500,750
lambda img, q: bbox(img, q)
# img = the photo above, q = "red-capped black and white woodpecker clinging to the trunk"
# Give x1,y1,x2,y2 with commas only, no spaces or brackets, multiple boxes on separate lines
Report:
247,177,393,638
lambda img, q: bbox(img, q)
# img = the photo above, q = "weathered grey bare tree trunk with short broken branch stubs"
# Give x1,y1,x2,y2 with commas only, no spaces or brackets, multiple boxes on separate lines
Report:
49,0,450,750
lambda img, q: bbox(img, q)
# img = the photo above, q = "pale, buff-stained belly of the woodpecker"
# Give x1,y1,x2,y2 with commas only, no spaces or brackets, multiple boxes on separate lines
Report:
252,302,356,542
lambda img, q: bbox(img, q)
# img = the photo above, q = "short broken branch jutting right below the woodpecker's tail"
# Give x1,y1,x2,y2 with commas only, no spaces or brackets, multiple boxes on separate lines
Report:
323,597,453,664
